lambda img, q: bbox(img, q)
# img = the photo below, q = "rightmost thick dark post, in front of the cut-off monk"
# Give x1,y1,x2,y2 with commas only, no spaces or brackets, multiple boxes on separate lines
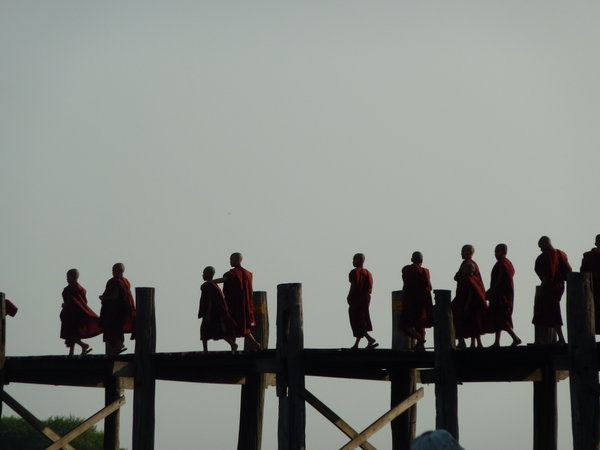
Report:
567,272,600,450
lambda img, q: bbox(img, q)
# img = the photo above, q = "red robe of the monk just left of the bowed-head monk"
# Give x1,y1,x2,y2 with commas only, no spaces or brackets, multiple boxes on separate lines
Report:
486,258,515,333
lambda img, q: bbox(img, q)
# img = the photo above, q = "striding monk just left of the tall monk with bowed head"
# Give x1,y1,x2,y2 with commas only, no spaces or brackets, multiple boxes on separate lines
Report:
486,244,522,347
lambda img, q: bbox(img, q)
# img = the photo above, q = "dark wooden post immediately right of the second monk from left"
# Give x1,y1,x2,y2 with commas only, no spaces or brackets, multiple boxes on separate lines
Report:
132,287,156,450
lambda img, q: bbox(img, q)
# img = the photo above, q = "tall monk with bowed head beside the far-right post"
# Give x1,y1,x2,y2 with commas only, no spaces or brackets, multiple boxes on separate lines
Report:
532,236,572,345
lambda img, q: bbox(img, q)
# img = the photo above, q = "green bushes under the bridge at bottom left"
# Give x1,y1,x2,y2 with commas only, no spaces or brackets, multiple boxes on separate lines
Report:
0,416,104,450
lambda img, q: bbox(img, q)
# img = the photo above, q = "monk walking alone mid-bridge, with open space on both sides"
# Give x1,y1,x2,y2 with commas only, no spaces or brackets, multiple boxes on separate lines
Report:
347,253,379,350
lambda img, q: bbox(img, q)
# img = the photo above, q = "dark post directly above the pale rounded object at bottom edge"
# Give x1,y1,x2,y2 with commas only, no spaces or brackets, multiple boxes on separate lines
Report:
433,289,458,441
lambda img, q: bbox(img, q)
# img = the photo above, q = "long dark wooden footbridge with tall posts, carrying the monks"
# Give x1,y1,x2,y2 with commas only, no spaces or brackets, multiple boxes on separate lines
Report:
0,273,600,450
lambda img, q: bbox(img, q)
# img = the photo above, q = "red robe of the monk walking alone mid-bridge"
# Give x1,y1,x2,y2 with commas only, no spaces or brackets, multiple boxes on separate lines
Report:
347,267,373,337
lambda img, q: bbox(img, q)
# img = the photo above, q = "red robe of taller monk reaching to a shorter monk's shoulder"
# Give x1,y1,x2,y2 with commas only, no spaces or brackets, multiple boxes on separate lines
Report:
223,267,254,337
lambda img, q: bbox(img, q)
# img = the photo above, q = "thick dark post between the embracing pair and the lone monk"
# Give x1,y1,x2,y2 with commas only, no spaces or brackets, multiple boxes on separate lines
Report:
276,283,306,450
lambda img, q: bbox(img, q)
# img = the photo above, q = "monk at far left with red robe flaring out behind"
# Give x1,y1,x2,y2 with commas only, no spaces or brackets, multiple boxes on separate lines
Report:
60,269,102,356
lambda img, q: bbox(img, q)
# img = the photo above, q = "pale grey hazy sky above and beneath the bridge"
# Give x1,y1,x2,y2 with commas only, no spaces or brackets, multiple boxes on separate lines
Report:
0,0,600,450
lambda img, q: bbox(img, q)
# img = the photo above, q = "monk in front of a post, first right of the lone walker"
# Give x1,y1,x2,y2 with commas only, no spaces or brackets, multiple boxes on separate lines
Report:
400,252,433,350
